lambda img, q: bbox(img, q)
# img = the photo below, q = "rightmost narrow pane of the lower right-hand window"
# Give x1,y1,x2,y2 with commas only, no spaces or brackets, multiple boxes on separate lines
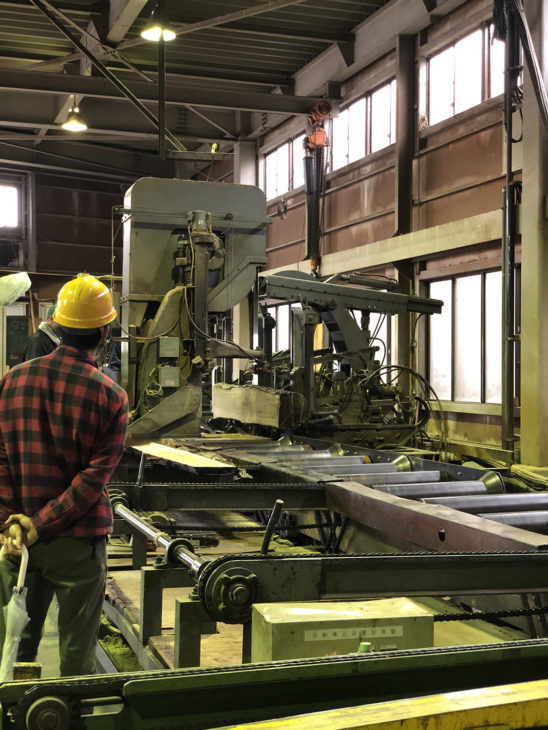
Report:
485,271,502,403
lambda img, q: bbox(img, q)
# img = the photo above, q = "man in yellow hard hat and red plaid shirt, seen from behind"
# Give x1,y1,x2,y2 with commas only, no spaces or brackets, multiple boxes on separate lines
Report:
0,275,128,676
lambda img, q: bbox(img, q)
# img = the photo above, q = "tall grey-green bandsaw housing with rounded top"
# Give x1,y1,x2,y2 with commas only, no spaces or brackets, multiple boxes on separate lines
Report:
121,178,267,443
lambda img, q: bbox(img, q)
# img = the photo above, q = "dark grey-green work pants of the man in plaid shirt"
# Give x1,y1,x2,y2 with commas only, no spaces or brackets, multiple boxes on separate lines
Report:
0,537,107,677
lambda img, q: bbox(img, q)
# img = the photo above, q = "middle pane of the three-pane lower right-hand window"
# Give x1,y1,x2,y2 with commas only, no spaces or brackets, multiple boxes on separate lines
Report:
455,274,481,402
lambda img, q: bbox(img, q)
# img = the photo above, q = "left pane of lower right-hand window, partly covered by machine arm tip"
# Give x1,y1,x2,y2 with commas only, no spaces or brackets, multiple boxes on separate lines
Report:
430,280,453,400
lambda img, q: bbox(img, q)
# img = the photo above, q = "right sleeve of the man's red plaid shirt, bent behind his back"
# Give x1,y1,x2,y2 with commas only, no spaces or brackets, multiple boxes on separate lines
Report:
32,397,128,537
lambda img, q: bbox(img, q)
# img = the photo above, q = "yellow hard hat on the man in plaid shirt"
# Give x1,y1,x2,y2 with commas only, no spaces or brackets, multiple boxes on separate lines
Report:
53,274,116,334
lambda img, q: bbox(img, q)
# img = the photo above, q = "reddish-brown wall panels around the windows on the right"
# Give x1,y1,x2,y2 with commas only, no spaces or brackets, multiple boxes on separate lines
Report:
260,0,510,445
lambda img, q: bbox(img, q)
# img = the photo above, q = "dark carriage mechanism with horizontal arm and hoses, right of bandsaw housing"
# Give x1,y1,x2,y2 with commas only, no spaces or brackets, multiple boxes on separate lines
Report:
250,271,443,448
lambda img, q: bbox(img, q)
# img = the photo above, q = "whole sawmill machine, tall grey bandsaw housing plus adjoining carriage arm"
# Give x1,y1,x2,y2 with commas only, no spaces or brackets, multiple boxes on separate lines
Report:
121,178,442,447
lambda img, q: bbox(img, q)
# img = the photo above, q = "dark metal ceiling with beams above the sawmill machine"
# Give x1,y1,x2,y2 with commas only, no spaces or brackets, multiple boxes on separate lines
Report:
0,0,388,174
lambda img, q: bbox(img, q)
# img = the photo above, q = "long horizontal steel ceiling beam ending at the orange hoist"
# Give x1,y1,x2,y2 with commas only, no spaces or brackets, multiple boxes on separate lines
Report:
0,69,320,115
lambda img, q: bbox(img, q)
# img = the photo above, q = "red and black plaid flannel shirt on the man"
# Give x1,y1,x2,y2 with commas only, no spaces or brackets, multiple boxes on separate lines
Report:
0,345,128,539
